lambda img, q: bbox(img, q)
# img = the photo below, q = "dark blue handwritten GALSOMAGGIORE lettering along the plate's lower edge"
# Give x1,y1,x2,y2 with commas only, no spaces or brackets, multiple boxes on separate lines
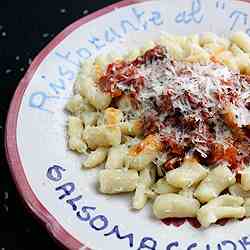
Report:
46,164,250,250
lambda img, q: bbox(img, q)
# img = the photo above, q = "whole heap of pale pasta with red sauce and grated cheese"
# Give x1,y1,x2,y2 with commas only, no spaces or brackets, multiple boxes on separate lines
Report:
65,32,250,227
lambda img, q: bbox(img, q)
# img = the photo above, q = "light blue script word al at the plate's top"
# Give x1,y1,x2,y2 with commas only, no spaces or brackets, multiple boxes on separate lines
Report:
175,0,204,24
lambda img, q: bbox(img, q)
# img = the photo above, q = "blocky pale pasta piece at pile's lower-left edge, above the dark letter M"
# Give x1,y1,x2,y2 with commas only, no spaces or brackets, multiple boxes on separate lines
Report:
99,169,139,194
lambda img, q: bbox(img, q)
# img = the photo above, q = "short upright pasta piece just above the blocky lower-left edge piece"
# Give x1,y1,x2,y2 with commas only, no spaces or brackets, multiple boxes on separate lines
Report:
105,145,128,169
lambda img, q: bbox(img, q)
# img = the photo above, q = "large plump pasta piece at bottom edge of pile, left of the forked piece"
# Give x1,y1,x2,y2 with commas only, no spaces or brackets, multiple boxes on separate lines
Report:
153,194,200,219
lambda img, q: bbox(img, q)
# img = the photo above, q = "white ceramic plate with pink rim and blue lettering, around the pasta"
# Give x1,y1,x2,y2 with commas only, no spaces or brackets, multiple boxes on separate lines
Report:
6,0,250,250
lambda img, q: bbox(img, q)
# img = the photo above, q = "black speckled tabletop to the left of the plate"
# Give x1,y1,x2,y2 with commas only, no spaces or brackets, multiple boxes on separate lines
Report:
0,0,118,250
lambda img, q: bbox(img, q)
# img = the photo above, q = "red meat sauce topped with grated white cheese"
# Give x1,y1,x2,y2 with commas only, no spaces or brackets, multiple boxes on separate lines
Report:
99,46,250,172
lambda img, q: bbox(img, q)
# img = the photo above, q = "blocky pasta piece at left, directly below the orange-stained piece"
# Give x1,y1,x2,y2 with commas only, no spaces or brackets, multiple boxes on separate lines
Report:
83,126,121,149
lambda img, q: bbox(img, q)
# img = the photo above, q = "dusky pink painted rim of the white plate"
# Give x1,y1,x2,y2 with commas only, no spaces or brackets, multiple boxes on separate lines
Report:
5,0,250,250
